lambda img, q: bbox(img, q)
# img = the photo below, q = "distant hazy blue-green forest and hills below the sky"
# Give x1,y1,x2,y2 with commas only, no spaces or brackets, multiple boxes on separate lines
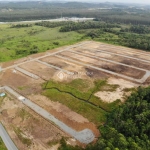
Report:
0,1,150,25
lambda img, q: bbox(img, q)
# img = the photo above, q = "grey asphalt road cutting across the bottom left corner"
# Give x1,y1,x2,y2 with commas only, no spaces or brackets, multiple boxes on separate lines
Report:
0,123,18,150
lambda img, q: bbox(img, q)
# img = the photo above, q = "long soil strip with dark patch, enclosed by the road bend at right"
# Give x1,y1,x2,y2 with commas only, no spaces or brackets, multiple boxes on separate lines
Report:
57,52,145,79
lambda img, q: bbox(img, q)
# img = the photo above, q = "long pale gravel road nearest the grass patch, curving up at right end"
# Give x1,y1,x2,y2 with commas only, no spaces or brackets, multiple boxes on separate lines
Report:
56,55,150,83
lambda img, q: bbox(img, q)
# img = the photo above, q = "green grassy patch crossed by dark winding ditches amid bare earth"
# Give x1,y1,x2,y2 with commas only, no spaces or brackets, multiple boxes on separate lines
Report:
43,79,119,125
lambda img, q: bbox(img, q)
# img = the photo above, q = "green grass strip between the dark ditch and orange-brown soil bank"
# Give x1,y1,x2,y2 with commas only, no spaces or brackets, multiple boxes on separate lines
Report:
43,89,106,124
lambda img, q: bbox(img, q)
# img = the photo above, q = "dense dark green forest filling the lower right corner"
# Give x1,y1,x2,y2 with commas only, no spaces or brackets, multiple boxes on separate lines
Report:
59,87,150,150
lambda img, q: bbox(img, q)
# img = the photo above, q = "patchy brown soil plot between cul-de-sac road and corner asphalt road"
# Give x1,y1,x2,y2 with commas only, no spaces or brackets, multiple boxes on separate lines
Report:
0,97,68,150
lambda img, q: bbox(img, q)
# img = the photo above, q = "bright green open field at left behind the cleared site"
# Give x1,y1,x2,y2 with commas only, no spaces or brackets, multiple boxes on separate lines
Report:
0,24,82,62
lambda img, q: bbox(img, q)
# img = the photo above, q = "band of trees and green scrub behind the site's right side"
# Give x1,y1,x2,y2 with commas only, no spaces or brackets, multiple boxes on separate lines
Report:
35,19,150,51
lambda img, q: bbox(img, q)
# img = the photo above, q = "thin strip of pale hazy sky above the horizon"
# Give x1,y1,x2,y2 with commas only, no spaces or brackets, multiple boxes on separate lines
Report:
0,0,150,4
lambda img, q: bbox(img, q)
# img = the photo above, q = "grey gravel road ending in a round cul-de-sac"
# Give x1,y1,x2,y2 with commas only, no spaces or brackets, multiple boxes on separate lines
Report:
4,86,95,144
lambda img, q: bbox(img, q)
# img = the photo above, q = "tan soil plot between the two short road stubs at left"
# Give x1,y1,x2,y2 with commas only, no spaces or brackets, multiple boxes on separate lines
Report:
20,62,57,80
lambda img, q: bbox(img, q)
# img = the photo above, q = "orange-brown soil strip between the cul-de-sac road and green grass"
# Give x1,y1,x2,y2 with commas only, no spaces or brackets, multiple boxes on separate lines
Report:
29,94,99,136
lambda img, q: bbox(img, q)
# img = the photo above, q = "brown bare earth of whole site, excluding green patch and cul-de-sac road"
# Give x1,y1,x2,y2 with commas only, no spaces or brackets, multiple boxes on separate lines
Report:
0,41,150,150
